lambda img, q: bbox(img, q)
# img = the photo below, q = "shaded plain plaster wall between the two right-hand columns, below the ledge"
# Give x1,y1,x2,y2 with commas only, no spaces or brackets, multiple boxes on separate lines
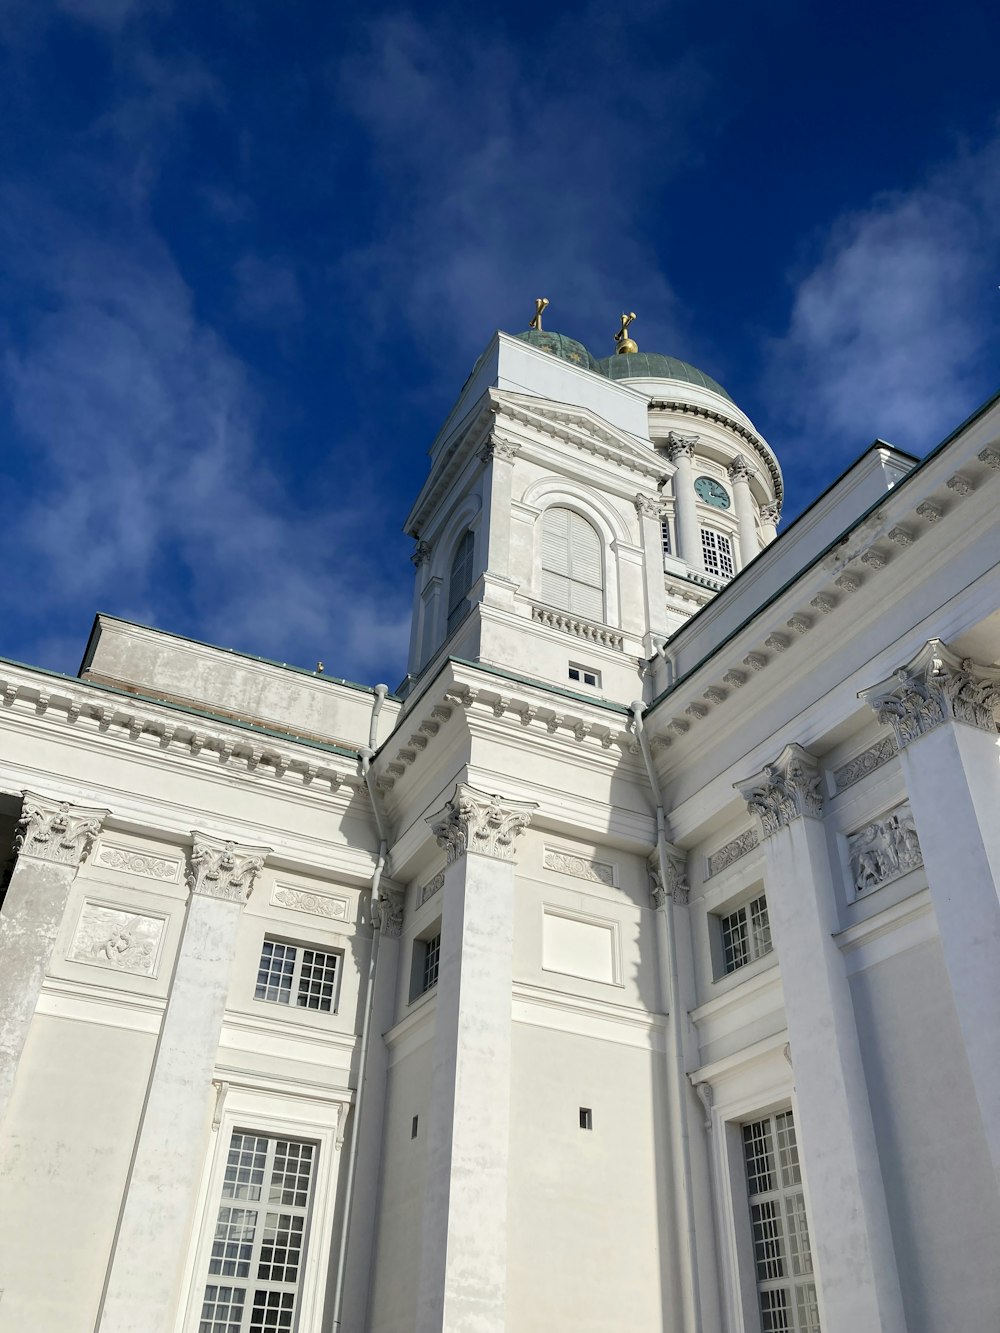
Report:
852,940,1000,1333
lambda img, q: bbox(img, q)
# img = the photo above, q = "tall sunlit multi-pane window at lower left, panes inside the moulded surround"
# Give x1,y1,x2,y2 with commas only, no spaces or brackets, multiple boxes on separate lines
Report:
197,1130,316,1333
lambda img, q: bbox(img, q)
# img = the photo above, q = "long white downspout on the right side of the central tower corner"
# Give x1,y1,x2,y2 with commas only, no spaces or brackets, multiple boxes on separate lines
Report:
631,701,701,1333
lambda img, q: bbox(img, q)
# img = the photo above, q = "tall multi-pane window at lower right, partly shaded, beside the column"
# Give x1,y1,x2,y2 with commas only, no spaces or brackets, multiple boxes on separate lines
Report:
743,1110,820,1333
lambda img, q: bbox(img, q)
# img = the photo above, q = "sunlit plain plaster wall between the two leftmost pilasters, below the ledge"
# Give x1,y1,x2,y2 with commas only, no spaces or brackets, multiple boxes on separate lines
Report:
0,1014,156,1333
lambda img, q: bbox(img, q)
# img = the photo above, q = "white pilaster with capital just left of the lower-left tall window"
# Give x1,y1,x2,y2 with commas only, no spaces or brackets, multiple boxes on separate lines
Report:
99,833,269,1333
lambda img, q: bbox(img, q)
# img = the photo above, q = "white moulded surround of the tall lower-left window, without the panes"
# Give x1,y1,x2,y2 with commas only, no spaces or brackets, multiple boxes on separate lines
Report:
175,1080,349,1333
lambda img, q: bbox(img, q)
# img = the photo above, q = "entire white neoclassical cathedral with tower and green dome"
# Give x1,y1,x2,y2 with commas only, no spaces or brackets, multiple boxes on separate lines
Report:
0,314,1000,1333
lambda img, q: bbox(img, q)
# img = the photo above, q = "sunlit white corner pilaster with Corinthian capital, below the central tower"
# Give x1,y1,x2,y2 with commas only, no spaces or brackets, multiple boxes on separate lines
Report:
415,784,535,1333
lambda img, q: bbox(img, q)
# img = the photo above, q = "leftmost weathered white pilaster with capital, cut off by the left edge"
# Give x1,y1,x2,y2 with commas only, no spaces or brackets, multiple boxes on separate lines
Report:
0,792,108,1124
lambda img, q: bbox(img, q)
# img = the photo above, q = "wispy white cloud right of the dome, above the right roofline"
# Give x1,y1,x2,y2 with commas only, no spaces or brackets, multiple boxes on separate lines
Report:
765,122,1000,490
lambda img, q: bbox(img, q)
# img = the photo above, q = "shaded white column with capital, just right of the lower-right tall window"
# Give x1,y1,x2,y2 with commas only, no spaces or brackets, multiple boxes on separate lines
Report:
737,745,905,1333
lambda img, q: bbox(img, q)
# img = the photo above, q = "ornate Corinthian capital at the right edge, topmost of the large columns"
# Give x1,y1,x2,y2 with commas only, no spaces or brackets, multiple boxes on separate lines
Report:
857,639,1000,749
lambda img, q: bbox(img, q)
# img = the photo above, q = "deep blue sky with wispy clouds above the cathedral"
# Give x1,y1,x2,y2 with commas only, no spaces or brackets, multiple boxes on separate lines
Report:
0,0,1000,685
